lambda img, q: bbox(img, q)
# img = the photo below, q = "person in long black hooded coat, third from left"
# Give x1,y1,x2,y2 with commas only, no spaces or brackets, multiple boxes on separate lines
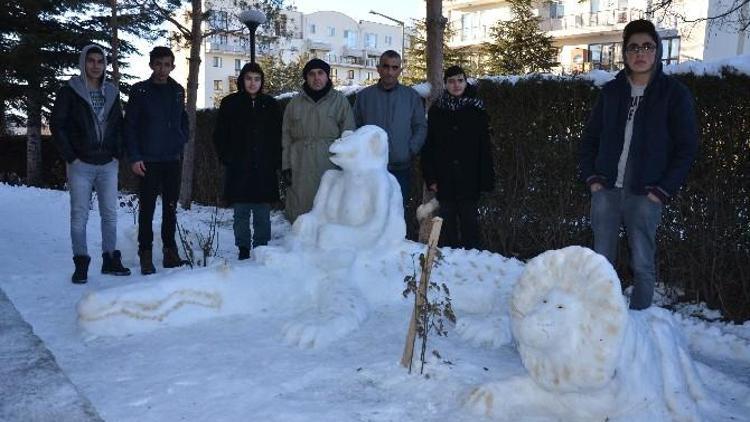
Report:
214,63,282,259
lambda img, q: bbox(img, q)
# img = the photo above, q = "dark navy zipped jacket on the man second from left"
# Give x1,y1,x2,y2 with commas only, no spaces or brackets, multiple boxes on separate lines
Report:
123,78,190,164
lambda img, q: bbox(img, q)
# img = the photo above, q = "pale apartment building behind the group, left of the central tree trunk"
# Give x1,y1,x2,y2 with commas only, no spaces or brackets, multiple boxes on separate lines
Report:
174,0,403,108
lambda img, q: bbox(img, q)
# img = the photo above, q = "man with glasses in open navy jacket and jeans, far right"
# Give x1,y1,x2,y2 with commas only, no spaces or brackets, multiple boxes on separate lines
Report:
580,20,698,309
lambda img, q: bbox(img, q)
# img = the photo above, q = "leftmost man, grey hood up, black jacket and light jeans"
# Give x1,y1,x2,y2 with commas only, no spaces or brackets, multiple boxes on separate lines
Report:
50,44,130,283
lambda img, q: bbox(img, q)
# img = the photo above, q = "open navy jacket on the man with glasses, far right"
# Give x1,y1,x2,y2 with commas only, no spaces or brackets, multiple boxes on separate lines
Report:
580,64,698,202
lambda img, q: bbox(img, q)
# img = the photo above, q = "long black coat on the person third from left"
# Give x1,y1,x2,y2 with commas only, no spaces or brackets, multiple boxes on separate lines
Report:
214,92,282,204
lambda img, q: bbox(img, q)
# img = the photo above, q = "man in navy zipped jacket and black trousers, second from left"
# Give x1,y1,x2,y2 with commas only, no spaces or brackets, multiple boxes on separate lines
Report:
124,47,189,274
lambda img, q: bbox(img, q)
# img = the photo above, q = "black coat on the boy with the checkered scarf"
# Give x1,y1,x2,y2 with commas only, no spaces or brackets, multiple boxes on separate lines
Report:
421,99,495,201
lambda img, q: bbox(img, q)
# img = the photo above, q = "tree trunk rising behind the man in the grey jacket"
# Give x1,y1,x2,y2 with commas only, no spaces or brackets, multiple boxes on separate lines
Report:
426,0,446,107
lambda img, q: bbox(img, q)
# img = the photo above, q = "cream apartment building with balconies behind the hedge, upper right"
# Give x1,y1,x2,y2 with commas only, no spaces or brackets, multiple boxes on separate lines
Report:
443,0,750,73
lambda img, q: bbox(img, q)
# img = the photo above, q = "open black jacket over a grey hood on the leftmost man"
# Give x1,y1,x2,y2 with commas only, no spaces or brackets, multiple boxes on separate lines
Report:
50,85,123,165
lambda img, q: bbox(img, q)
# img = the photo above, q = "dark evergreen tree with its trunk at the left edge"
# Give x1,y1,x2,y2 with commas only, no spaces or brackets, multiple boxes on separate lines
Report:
0,0,110,185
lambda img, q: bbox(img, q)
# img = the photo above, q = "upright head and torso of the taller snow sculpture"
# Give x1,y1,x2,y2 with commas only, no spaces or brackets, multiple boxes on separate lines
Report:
292,125,406,250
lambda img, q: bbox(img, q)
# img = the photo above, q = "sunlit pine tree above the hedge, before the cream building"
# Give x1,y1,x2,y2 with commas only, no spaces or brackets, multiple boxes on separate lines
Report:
484,0,557,75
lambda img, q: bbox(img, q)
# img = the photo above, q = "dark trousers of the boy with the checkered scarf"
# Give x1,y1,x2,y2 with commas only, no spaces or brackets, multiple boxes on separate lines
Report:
440,200,480,249
